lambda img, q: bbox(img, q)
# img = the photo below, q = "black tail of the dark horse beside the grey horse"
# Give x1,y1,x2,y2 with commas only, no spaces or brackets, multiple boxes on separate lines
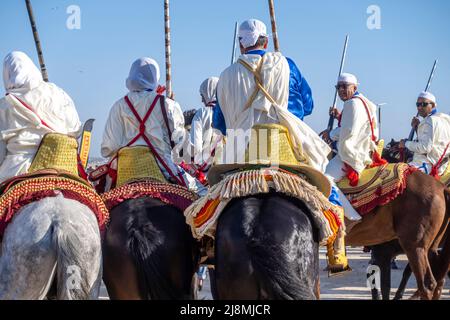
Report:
126,202,178,299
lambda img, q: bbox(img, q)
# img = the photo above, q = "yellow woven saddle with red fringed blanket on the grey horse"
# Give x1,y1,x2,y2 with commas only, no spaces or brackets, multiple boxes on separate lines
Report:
0,133,109,239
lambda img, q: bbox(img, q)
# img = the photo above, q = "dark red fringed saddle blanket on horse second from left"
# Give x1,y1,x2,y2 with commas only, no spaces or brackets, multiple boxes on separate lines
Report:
101,179,198,211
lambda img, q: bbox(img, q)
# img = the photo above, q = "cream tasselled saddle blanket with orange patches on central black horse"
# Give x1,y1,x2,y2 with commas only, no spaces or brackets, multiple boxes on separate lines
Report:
184,167,345,245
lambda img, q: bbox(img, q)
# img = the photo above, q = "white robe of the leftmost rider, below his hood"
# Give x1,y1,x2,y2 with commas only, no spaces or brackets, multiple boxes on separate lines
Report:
0,82,81,181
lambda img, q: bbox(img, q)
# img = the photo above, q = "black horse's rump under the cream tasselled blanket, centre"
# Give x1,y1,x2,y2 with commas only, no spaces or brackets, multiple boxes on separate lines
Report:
213,192,320,300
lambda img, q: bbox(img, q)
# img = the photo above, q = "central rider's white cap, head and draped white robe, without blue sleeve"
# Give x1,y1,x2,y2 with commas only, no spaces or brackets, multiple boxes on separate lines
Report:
213,19,331,172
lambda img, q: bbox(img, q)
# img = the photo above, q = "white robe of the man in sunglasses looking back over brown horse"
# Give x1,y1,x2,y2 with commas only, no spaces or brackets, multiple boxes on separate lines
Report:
327,94,378,175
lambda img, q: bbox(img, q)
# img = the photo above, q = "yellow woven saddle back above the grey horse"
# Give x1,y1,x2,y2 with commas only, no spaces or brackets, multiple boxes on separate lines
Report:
28,133,78,176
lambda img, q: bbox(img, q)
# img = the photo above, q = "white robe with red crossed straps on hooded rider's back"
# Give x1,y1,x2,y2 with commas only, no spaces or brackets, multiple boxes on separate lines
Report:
101,91,203,192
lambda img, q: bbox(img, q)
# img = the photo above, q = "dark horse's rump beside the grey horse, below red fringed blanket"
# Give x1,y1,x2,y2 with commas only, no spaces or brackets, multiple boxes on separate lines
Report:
103,196,199,300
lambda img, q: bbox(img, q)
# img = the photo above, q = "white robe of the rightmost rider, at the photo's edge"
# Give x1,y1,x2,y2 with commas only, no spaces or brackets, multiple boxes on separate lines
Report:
405,113,450,174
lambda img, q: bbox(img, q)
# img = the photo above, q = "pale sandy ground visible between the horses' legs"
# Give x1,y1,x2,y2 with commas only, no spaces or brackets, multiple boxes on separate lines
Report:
100,247,450,300
